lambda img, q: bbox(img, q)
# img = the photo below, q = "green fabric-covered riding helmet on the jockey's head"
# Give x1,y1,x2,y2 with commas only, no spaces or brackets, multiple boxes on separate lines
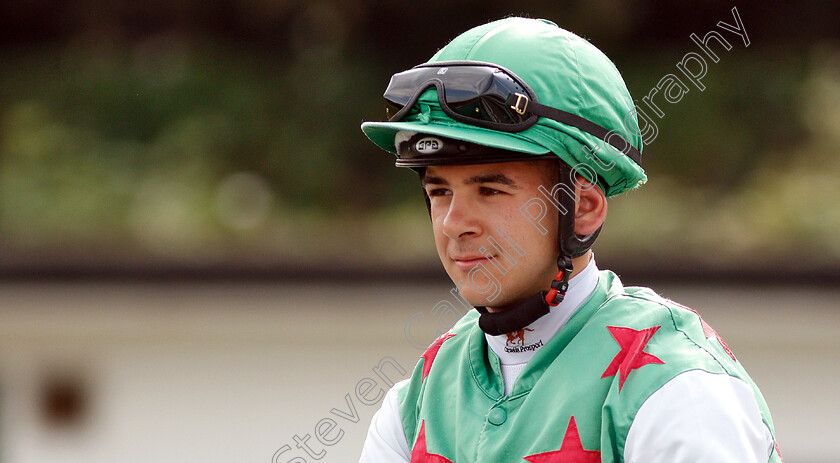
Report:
362,18,647,196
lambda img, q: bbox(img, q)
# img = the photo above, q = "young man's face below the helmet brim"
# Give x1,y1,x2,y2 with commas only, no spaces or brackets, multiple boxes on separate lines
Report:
423,161,559,309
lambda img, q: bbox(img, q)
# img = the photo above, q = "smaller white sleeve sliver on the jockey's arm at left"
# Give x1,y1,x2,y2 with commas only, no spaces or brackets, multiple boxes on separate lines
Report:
359,380,411,463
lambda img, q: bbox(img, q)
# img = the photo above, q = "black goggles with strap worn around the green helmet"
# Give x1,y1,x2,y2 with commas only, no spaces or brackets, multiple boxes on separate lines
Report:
383,61,642,165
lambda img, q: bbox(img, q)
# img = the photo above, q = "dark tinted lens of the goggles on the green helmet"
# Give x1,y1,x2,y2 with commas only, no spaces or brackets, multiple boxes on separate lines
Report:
384,65,533,124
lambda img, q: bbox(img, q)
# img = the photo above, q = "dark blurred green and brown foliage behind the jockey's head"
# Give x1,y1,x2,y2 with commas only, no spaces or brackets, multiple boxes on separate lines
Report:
0,0,840,283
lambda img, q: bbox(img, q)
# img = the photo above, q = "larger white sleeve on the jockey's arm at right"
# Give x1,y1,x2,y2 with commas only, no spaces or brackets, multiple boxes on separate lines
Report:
624,370,774,463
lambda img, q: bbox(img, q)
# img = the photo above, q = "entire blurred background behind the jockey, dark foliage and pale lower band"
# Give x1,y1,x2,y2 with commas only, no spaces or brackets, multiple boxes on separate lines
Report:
0,0,840,463
